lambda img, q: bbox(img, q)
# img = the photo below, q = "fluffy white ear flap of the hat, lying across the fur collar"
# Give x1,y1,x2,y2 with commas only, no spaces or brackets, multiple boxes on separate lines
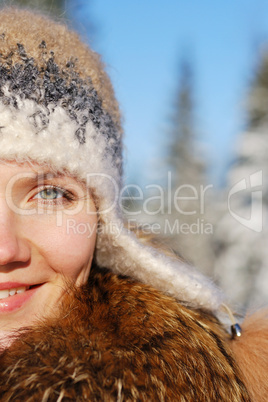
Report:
97,223,224,311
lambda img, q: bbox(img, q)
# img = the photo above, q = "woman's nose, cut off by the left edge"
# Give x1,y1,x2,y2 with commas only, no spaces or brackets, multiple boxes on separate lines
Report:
0,210,31,267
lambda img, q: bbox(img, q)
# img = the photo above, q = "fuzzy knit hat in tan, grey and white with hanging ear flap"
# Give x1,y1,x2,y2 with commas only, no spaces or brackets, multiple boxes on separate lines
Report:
0,8,221,310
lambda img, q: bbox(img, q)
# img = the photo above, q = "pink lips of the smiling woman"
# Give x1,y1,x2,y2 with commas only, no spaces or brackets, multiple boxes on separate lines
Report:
0,282,43,314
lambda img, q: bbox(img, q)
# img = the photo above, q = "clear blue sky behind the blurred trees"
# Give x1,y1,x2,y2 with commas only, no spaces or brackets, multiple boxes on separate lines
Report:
68,0,268,184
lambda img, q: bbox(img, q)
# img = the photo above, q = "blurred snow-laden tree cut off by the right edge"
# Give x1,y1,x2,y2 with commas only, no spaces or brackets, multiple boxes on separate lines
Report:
215,54,268,307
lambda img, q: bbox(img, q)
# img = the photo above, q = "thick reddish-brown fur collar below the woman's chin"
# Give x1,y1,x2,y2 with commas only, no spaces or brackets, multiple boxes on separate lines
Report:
0,267,250,402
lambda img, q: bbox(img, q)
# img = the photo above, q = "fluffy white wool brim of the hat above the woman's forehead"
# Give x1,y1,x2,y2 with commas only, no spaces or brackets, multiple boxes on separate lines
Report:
0,99,120,210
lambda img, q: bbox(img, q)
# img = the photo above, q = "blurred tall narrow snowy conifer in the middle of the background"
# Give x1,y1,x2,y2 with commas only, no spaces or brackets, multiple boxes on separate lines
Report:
165,59,216,274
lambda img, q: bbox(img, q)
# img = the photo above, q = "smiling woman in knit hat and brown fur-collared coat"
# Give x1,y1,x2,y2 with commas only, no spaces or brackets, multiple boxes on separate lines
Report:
0,9,268,401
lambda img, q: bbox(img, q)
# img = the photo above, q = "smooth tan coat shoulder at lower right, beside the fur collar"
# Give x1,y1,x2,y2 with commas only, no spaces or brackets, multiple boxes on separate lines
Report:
228,309,268,402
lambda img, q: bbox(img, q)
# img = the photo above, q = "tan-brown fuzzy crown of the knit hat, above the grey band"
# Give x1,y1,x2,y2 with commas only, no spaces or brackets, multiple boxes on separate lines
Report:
0,8,120,126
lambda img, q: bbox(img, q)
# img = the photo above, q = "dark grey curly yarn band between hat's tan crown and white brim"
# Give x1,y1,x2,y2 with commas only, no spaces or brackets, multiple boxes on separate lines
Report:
0,41,122,171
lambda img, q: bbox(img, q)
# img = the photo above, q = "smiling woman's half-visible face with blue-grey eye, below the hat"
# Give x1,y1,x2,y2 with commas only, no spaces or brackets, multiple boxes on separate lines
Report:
0,162,97,335
